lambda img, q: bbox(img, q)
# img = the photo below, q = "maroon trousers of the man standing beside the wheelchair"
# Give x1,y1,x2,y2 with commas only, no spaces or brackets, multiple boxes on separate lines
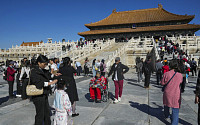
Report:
114,80,123,99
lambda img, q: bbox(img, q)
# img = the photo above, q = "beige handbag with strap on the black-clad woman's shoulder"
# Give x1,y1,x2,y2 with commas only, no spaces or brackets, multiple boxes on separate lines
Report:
26,68,43,96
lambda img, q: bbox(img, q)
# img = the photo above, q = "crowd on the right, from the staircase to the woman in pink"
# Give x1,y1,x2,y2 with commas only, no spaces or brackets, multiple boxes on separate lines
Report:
136,36,200,125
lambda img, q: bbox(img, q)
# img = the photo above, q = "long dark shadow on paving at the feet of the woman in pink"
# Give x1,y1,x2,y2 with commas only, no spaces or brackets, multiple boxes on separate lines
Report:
129,101,192,125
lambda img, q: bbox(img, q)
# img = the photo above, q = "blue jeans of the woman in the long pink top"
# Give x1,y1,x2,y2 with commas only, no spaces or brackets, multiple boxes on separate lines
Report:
164,106,179,125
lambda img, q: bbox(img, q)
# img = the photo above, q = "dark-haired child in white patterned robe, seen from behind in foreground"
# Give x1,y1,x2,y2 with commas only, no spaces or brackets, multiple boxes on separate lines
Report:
53,79,73,125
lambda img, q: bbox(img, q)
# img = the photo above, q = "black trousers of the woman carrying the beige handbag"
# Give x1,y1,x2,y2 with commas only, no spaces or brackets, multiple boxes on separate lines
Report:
32,95,51,125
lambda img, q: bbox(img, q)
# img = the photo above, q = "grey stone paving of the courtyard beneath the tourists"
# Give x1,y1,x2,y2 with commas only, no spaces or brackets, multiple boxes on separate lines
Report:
0,69,198,125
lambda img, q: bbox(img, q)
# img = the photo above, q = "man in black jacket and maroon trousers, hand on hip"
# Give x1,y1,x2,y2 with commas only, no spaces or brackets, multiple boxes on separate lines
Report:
108,57,129,103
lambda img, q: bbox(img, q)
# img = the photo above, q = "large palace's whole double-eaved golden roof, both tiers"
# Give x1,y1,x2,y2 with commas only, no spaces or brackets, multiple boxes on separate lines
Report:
78,4,200,40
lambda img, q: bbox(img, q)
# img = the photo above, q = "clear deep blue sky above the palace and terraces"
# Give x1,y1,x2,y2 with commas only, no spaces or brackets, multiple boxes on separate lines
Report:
0,0,200,48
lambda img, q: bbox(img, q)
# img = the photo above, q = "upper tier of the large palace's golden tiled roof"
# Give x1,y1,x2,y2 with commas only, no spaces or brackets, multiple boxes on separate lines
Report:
85,7,194,27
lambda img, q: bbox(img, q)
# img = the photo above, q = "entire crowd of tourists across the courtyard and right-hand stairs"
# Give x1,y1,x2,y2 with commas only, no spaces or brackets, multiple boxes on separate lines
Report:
1,35,200,125
